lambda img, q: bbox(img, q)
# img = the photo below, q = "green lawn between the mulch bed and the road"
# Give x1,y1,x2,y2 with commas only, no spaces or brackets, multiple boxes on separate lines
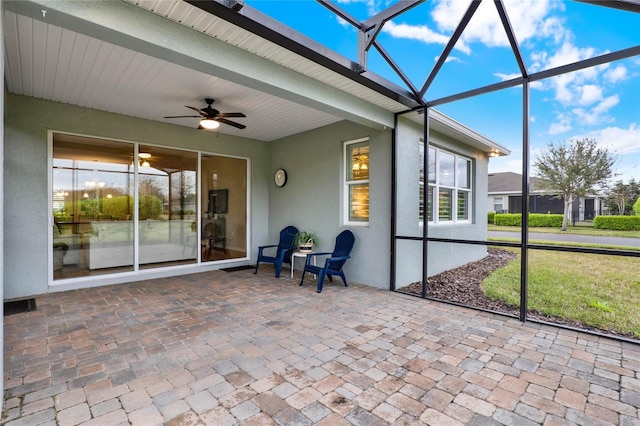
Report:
482,250,640,338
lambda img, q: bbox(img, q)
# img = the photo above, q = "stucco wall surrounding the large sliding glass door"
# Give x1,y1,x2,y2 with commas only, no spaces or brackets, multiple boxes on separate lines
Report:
3,94,272,299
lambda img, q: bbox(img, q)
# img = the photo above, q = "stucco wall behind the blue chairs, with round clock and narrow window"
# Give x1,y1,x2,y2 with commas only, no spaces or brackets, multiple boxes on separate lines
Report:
269,121,391,289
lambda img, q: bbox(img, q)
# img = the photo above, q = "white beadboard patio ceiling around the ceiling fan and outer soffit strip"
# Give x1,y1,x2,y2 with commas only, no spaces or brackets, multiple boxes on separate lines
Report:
4,1,396,141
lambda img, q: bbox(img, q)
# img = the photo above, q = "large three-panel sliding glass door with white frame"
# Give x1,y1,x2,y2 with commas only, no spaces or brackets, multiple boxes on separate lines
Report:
51,133,248,280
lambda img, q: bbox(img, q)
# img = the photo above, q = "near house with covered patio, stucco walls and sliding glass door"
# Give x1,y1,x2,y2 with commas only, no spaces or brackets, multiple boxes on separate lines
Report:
3,1,508,300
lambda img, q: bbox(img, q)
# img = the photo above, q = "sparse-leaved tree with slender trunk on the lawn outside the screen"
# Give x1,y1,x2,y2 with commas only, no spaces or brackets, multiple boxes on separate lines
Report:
533,138,616,231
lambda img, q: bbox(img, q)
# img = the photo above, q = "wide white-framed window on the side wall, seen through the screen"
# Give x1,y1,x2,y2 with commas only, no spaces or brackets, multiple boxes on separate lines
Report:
419,143,472,224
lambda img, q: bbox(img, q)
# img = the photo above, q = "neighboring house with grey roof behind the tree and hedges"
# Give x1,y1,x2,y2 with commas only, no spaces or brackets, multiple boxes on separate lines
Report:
487,172,604,222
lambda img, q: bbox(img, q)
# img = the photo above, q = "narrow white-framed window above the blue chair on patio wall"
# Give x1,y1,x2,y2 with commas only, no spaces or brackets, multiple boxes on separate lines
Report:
343,138,369,225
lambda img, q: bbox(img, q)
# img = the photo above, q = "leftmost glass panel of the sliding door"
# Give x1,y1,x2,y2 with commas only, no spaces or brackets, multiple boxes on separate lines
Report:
52,134,135,279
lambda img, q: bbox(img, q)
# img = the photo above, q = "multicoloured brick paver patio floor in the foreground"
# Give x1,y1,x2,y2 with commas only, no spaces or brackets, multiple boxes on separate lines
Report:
3,267,640,426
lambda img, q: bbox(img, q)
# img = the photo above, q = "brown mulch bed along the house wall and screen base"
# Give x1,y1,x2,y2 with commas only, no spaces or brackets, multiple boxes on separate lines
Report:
398,248,638,340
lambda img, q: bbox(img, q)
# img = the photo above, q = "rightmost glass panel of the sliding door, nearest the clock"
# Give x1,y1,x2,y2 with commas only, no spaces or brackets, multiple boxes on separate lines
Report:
200,155,247,262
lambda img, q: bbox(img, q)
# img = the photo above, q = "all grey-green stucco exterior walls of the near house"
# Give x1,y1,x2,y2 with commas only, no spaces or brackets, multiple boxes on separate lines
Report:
4,95,496,299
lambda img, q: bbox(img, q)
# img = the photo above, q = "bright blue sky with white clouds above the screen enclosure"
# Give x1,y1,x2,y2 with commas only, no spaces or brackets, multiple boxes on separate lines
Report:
246,0,640,181
